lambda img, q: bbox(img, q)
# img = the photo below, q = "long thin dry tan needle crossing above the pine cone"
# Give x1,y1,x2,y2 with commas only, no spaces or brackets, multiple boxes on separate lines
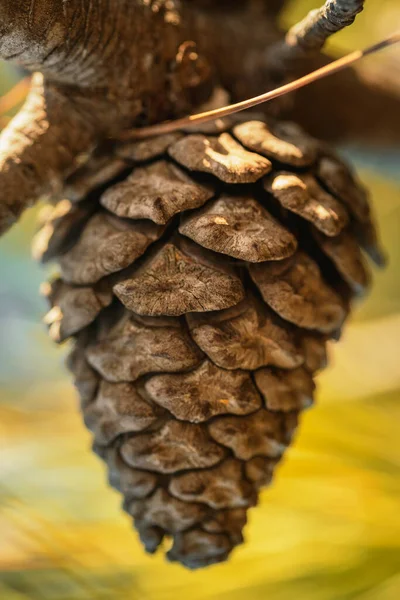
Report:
119,31,400,141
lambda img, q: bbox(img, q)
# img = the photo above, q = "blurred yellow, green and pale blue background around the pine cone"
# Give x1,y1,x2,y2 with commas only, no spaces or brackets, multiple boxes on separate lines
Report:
0,0,400,600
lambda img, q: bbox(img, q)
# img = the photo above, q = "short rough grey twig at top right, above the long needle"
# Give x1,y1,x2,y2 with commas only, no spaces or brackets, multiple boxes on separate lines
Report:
268,0,365,73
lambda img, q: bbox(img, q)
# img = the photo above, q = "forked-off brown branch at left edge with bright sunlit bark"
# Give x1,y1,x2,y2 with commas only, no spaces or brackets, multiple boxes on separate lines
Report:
0,74,106,232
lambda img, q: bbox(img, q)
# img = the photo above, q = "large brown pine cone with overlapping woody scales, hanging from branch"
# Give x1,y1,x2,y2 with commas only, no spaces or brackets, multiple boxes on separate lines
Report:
34,115,383,568
